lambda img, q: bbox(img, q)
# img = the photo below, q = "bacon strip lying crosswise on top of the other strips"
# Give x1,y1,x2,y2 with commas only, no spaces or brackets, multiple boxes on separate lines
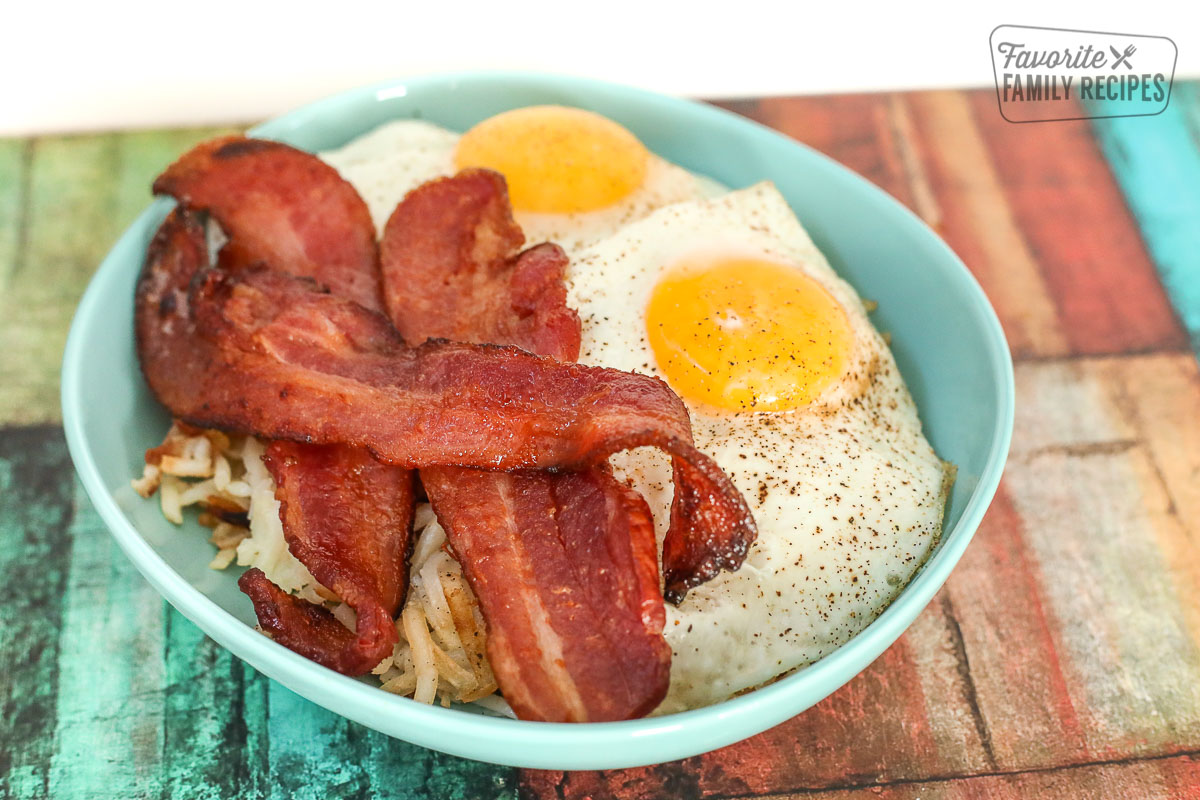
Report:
181,270,734,482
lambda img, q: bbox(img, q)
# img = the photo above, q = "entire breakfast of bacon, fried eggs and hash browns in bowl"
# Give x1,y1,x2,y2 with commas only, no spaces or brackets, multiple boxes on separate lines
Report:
137,107,953,721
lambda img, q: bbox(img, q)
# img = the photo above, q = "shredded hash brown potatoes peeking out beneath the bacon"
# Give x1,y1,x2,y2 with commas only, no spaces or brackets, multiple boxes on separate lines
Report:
131,422,514,716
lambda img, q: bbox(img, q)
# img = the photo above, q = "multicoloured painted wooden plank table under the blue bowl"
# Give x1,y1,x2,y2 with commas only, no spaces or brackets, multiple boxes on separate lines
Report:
0,84,1200,799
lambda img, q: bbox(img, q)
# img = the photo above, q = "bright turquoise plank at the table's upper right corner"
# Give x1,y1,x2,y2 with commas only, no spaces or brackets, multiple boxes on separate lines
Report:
1080,82,1200,355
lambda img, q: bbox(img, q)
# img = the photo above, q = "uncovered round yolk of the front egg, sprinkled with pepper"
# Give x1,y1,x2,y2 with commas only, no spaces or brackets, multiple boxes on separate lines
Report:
646,258,853,411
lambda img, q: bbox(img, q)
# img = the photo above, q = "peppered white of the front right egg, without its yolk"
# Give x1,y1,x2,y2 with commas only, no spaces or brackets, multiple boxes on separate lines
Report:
568,184,947,714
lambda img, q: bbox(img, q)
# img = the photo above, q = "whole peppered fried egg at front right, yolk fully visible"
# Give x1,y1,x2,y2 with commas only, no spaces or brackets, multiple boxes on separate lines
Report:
566,184,950,714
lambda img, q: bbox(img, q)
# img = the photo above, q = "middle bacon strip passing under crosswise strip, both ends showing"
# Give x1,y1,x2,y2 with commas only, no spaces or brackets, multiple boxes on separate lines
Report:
382,170,671,722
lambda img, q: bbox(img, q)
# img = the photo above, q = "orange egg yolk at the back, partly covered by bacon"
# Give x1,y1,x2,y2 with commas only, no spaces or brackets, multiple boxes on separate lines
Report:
455,106,649,213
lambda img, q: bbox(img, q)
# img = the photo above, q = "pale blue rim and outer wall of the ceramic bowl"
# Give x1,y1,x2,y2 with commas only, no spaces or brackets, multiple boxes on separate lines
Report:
61,72,1014,769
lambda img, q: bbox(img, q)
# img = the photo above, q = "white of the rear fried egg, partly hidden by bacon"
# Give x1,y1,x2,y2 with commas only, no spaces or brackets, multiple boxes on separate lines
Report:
320,120,724,254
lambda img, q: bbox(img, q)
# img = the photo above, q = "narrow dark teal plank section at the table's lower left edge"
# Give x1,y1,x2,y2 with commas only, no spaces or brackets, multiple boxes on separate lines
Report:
0,427,75,800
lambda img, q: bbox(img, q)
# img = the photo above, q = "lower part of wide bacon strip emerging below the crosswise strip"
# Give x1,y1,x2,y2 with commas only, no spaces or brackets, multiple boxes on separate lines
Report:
421,468,671,722
